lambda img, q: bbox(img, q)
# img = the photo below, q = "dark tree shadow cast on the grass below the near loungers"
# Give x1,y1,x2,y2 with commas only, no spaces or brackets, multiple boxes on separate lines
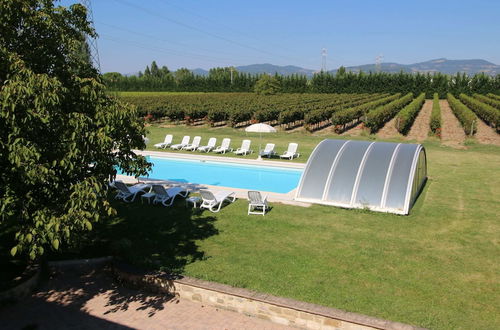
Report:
99,200,219,274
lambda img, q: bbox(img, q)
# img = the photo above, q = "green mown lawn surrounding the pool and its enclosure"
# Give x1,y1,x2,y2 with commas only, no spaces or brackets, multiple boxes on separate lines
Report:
54,127,500,329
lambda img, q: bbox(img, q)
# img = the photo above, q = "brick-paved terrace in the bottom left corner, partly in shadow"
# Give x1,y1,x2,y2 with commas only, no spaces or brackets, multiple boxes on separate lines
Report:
0,270,288,329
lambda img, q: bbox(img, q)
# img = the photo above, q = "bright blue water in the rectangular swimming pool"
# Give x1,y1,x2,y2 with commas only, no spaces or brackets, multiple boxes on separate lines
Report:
138,157,302,193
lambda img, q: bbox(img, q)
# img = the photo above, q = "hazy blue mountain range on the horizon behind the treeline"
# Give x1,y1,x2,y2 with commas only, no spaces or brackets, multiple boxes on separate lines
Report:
192,58,500,77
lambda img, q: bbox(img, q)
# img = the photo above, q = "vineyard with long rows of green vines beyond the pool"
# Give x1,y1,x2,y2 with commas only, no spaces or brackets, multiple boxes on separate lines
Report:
117,92,500,144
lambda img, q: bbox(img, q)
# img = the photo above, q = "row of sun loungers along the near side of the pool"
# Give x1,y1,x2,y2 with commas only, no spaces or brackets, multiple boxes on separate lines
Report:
111,180,269,215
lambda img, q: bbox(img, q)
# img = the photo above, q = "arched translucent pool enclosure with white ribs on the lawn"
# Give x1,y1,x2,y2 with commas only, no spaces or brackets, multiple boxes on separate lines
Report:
295,140,427,214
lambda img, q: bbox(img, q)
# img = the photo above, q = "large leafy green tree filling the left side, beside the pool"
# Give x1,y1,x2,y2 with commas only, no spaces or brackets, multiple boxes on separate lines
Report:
0,0,148,259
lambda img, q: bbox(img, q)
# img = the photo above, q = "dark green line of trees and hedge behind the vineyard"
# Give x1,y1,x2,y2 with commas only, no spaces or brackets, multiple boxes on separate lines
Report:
103,61,500,94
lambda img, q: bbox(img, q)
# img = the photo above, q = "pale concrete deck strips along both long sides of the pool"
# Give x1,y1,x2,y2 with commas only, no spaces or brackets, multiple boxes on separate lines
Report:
116,150,311,207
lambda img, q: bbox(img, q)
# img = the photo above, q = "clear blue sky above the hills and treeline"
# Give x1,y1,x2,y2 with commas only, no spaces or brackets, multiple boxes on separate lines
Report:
61,0,500,73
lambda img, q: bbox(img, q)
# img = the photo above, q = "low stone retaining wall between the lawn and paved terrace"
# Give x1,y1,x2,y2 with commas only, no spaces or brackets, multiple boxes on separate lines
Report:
113,265,422,330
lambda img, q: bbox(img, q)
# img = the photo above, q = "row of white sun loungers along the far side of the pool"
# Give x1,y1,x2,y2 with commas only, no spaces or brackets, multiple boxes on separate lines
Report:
154,134,300,159
